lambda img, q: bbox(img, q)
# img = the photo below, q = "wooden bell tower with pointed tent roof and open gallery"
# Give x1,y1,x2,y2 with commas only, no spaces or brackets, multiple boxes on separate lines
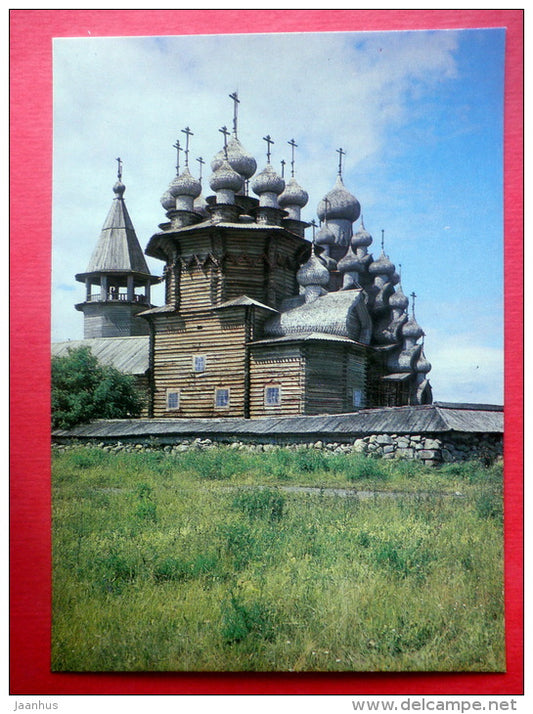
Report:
76,159,159,339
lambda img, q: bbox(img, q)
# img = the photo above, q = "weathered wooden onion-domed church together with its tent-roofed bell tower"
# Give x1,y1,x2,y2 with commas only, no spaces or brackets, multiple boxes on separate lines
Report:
61,94,432,418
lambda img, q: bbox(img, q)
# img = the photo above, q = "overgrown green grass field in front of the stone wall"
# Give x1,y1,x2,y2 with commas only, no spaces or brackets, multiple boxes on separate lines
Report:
52,447,505,671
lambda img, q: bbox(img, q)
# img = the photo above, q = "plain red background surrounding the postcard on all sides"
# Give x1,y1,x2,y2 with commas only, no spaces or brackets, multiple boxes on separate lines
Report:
10,10,523,695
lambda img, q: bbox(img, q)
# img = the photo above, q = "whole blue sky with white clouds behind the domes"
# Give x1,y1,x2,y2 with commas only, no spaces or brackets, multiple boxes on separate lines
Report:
52,29,505,403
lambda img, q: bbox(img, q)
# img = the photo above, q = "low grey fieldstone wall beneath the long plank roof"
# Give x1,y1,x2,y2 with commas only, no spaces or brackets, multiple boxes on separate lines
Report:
55,433,503,466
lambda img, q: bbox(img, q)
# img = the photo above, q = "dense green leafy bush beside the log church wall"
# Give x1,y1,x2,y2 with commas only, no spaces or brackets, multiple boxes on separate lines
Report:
52,347,143,429
